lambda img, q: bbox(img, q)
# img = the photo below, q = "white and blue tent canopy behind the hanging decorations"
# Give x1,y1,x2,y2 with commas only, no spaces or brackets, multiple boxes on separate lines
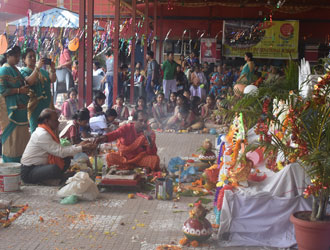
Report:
9,8,79,28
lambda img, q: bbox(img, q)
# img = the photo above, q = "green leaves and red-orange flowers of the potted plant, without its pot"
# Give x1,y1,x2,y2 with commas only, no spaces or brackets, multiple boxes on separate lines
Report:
247,73,330,221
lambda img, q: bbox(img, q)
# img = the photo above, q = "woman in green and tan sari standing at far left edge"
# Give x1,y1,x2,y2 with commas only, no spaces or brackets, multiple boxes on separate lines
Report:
0,46,30,162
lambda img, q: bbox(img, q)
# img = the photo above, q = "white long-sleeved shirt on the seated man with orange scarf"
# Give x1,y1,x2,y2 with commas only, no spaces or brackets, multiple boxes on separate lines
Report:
21,127,82,166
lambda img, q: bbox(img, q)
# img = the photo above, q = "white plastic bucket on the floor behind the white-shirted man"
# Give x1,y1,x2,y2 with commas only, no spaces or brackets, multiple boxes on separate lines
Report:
0,163,21,192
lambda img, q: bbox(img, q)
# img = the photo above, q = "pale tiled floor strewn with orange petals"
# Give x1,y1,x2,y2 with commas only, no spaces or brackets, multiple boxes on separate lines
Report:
0,134,286,250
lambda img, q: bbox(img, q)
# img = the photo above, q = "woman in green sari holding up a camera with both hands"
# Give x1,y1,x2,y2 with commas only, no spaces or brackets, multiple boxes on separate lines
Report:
21,48,56,133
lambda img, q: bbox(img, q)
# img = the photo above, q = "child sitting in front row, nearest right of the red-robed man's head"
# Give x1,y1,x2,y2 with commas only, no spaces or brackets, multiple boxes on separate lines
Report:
150,93,168,129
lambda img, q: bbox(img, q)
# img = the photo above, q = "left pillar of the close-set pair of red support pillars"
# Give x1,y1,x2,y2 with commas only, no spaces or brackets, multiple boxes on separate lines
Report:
78,0,86,108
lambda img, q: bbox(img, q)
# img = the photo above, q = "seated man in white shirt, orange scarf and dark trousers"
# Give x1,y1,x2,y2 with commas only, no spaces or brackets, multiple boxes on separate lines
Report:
21,109,97,185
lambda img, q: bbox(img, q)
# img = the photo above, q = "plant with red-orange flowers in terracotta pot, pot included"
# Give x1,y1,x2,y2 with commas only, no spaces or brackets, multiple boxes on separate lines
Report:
246,69,330,250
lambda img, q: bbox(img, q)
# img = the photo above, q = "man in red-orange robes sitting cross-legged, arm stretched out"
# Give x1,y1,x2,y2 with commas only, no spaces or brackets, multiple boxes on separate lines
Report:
97,110,159,171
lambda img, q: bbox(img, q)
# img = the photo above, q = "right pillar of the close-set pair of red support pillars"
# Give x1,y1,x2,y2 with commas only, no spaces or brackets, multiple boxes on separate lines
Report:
86,0,94,105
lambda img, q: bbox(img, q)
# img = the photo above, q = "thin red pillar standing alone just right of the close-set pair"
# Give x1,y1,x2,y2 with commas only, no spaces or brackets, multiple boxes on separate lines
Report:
113,0,120,104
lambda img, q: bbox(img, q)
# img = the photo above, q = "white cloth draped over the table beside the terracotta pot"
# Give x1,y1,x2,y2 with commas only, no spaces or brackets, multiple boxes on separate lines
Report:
218,129,311,247
